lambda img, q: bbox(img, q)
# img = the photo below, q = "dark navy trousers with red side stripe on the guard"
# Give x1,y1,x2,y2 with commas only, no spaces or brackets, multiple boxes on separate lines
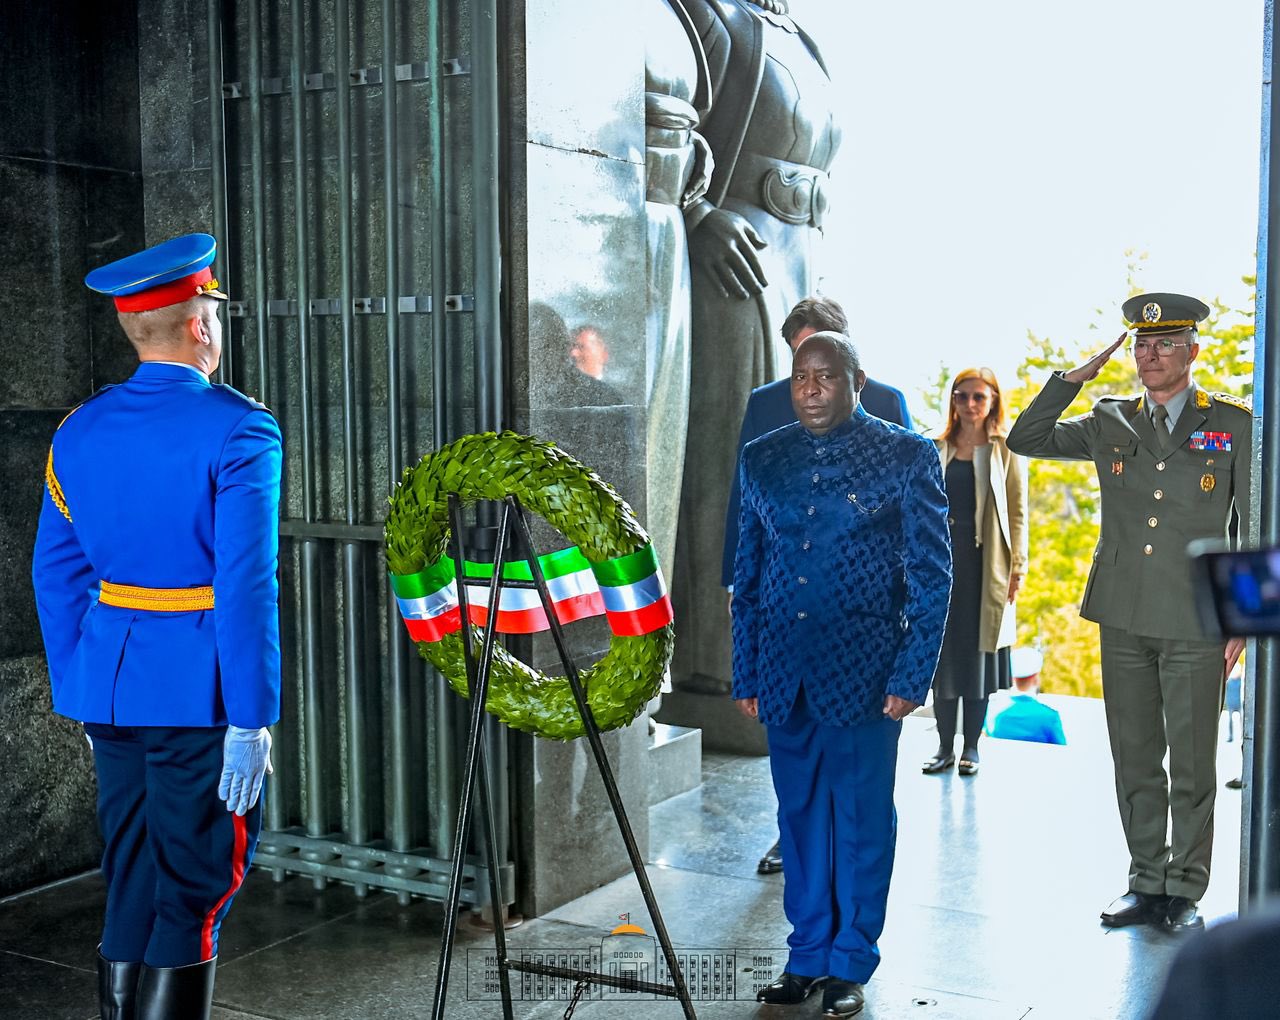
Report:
84,723,262,968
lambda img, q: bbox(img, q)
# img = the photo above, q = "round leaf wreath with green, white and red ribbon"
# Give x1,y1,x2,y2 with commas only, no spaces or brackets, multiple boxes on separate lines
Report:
385,431,675,740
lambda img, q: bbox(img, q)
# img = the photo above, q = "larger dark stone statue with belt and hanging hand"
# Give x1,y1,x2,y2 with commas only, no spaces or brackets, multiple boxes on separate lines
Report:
670,0,840,694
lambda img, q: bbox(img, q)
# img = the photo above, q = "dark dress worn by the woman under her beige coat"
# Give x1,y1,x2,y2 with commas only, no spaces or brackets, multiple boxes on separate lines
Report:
933,458,1012,699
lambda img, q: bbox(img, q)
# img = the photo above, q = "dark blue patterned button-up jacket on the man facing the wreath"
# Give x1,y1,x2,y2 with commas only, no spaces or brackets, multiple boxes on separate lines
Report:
732,408,951,726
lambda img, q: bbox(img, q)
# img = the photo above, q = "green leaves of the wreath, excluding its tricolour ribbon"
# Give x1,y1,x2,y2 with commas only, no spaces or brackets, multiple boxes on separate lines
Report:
385,431,675,740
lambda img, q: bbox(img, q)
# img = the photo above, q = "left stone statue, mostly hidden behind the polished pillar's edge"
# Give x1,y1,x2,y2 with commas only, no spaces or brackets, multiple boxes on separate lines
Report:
639,0,712,573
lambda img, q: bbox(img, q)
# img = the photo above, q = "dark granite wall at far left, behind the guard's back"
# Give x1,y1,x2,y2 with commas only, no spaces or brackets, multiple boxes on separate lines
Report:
0,0,142,896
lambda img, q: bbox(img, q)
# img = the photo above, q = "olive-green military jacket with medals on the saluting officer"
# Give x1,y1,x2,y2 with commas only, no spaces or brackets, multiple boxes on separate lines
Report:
1007,372,1253,639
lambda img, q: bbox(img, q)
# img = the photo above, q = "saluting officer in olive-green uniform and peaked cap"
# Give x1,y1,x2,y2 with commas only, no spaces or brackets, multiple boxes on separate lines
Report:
1009,294,1252,932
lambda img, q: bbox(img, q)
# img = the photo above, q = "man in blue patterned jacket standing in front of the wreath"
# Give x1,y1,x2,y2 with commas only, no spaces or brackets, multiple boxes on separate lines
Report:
732,333,951,1017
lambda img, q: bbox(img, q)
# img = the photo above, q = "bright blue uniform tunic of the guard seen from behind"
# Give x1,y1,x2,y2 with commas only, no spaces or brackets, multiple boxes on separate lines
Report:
32,362,280,727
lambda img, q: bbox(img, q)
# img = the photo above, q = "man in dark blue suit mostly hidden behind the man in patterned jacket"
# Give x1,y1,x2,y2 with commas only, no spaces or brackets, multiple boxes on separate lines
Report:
721,297,911,875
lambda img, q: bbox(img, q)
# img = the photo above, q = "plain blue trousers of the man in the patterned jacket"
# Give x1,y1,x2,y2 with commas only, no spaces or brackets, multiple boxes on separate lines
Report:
768,687,902,983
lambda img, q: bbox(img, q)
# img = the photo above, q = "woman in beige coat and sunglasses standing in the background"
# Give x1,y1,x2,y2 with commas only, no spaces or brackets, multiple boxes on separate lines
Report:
924,369,1027,776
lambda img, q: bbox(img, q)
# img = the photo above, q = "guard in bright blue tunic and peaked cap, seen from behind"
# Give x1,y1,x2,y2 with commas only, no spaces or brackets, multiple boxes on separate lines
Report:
32,234,280,1020
